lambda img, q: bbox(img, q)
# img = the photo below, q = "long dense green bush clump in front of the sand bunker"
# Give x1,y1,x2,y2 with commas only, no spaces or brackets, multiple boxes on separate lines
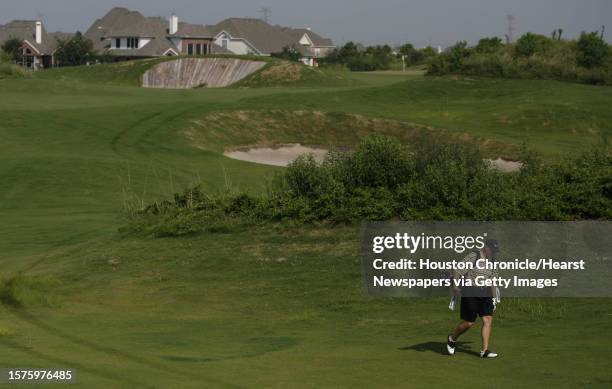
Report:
128,135,612,236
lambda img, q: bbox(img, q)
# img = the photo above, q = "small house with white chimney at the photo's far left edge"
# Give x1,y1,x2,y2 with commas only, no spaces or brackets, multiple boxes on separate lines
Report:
0,20,72,69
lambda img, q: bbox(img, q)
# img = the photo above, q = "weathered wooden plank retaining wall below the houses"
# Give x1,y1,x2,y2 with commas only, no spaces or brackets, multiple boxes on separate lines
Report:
142,58,266,89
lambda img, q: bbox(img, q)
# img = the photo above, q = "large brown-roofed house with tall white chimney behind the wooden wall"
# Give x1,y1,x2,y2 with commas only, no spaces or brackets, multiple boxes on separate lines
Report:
85,7,224,59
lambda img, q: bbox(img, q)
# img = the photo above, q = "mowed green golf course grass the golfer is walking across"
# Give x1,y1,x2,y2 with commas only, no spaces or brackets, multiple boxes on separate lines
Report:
0,62,612,388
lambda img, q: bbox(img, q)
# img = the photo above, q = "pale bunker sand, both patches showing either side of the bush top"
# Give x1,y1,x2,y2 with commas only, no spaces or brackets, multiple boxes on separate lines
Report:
223,144,523,173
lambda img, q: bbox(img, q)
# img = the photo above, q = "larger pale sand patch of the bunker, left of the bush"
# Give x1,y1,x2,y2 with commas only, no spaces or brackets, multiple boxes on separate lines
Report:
223,144,327,166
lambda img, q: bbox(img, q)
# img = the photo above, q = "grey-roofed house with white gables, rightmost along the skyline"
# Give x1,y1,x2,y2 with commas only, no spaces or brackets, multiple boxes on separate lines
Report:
211,18,335,66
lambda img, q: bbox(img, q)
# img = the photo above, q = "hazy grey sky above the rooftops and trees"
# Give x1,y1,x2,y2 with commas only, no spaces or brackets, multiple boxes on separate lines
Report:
0,0,612,46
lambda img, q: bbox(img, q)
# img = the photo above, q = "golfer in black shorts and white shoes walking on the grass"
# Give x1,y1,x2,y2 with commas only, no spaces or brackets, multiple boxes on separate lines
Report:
446,239,499,358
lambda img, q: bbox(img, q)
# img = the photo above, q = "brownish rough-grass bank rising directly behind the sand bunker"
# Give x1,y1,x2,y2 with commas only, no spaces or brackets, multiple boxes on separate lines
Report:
182,110,520,159
